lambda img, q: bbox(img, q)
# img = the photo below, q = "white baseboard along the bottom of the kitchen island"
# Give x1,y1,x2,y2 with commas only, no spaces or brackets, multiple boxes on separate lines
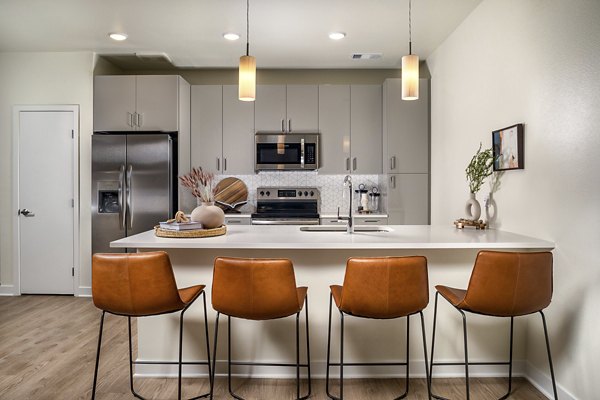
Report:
135,360,525,379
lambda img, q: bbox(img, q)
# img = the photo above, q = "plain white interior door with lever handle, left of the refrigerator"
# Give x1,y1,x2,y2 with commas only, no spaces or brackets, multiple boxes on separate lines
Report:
15,111,76,294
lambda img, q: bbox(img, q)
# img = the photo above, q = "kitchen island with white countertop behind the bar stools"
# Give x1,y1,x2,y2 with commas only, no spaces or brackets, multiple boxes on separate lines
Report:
111,225,554,377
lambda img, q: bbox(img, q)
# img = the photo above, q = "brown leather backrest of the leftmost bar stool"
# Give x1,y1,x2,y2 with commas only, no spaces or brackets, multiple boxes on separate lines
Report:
92,251,185,317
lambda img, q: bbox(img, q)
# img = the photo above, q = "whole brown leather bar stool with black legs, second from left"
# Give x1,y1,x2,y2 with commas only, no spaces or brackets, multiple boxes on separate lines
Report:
211,257,311,400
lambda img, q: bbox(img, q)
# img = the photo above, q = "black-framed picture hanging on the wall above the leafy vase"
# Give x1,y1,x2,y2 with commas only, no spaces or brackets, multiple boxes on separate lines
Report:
492,124,525,171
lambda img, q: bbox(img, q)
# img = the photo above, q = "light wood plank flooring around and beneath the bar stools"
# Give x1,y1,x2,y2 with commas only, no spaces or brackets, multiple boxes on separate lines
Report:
0,296,545,400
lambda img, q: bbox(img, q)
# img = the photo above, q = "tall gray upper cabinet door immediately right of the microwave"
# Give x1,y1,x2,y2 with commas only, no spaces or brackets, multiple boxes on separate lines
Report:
319,85,350,174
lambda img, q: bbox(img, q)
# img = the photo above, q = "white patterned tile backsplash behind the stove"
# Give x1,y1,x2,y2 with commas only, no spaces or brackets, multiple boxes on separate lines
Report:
215,171,387,214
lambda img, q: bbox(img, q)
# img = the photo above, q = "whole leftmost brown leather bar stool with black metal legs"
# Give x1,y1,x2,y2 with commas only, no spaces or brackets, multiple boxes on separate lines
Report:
92,251,212,400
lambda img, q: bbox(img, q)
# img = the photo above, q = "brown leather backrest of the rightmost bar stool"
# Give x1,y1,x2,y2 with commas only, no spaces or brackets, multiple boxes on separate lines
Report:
458,251,552,317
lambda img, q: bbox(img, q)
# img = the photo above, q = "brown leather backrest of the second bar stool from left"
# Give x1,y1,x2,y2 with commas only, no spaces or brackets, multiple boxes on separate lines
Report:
212,257,304,320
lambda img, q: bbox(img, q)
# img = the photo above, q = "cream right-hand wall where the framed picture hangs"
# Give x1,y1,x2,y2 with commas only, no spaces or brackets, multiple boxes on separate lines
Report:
427,0,600,399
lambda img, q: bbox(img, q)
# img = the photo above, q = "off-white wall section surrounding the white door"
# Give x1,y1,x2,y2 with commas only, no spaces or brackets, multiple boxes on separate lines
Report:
0,52,94,294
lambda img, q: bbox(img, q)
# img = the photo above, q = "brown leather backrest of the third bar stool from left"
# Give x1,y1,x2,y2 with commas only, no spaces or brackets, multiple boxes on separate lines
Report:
340,256,429,319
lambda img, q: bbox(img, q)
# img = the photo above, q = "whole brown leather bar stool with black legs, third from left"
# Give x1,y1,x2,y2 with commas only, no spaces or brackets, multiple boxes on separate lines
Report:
325,256,430,400
